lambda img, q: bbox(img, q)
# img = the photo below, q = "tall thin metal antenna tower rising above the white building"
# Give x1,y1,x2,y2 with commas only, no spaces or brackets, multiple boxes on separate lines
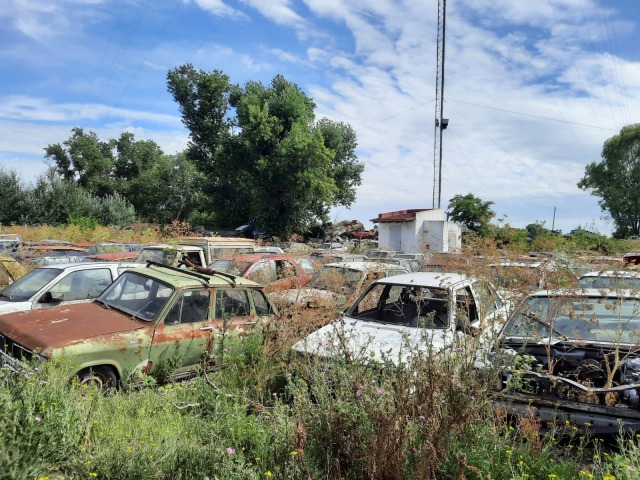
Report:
433,0,449,208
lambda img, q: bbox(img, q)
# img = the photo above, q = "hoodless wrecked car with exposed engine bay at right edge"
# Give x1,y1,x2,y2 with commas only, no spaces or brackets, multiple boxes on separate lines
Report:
493,289,640,433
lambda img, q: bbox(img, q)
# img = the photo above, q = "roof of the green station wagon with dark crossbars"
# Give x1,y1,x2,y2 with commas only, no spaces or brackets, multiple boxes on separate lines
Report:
127,263,262,289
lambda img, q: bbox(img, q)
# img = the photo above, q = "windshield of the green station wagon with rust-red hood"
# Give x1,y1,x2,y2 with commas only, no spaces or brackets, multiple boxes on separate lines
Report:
98,272,173,322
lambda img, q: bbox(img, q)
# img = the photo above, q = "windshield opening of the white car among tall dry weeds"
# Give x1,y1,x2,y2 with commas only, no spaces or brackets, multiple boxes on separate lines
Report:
347,283,449,328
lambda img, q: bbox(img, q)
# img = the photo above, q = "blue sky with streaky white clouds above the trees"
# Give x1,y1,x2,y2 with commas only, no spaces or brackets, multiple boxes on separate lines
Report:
0,0,640,235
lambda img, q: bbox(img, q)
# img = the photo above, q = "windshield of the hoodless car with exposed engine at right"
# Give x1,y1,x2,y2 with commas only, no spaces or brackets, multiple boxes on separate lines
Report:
501,296,640,344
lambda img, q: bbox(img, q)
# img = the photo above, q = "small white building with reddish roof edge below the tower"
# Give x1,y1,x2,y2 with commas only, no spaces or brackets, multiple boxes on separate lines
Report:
371,208,462,253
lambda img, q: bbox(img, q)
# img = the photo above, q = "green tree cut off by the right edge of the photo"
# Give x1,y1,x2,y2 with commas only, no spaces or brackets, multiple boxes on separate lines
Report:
578,123,640,238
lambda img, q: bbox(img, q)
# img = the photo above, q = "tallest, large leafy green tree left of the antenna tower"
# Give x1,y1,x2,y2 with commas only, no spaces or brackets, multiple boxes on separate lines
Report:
168,65,364,237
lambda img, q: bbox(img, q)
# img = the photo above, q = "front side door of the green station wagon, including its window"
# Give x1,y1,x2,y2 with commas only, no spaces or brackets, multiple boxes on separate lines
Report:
149,288,215,376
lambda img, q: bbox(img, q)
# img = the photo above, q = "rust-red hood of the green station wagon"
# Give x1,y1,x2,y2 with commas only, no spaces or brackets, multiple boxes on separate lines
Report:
0,302,150,350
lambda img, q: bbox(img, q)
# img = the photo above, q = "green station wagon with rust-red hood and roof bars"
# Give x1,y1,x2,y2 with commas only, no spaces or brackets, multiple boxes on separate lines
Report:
0,263,276,388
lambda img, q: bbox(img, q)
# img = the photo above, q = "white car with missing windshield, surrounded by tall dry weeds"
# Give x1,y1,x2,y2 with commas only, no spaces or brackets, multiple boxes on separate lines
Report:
293,272,506,365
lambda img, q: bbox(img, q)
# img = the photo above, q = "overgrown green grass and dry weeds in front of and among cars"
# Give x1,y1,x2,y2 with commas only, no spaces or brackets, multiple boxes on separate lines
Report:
0,228,640,480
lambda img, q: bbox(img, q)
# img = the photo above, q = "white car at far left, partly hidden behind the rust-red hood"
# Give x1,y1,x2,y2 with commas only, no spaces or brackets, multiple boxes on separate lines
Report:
0,262,141,315
